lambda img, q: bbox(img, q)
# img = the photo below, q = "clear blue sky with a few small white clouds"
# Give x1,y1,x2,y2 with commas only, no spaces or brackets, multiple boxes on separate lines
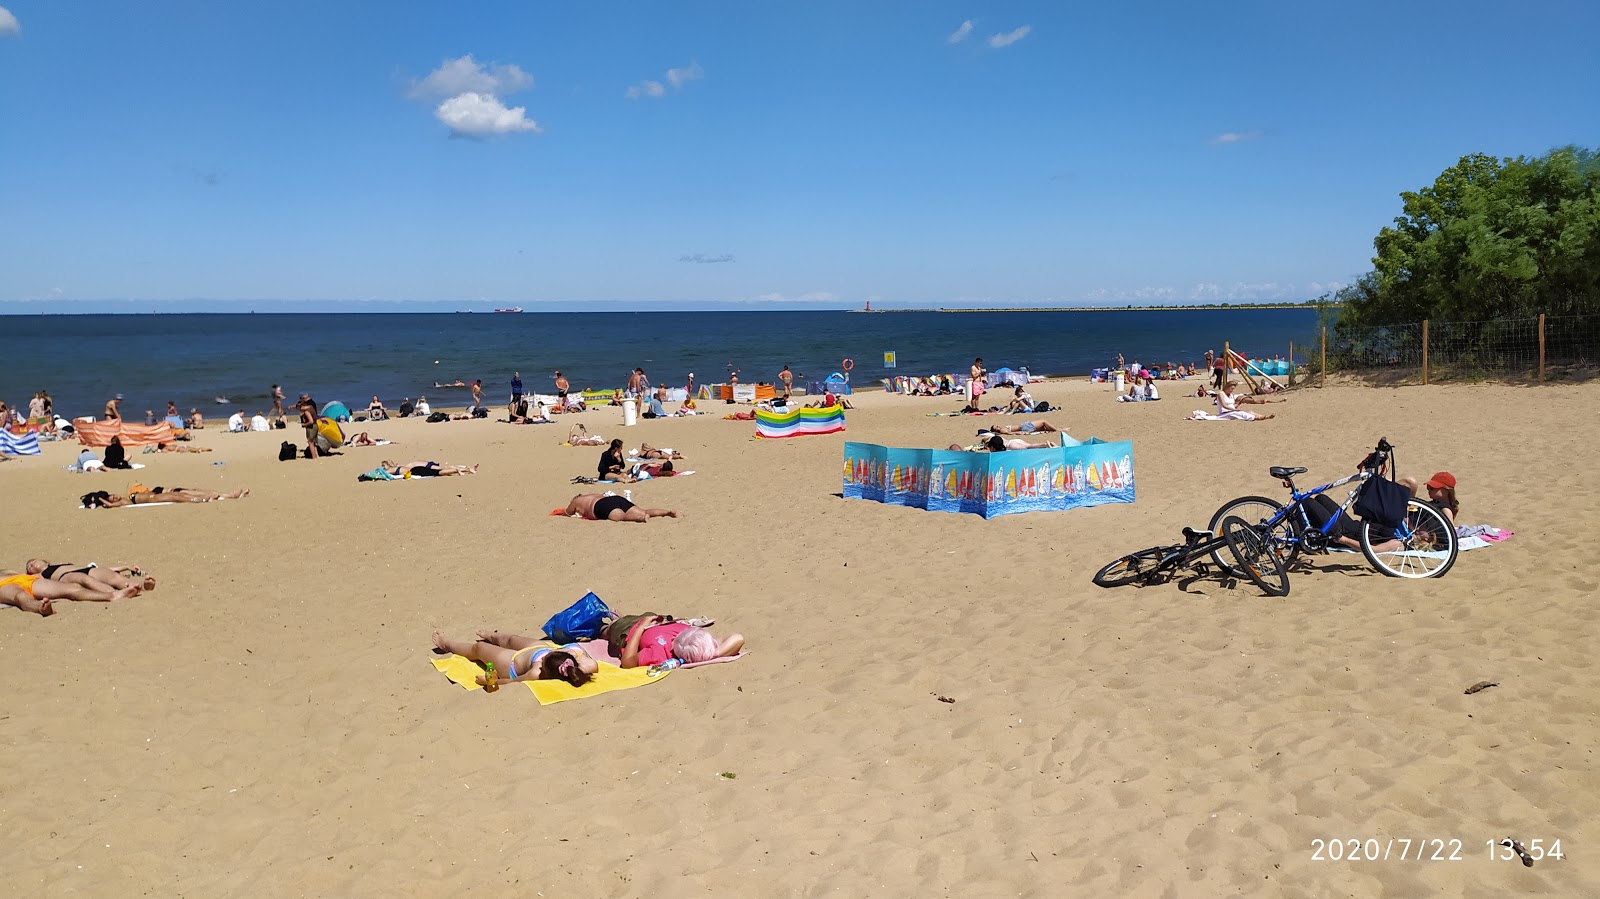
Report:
0,0,1600,312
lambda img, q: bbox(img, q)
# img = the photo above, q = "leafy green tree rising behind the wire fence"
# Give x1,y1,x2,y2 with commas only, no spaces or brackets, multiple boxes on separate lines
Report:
1339,147,1600,326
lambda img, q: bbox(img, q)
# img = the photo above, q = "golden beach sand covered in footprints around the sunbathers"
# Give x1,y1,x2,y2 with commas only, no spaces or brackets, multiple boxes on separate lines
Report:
0,381,1600,897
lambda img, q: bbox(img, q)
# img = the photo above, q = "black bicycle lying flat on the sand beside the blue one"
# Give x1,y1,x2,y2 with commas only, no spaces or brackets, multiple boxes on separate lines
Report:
1094,515,1290,597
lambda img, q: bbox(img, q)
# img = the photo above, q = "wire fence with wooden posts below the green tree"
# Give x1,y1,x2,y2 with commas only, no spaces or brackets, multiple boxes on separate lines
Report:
1296,315,1600,384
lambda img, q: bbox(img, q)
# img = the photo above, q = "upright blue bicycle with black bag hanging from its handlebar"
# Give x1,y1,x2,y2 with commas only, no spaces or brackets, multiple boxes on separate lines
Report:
1211,438,1461,577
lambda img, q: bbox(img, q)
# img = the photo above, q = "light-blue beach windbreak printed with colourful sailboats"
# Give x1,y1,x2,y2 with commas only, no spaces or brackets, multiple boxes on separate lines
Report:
843,435,1134,518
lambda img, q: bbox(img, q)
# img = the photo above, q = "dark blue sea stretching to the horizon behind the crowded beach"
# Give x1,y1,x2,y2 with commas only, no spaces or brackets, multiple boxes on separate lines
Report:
0,309,1317,418
